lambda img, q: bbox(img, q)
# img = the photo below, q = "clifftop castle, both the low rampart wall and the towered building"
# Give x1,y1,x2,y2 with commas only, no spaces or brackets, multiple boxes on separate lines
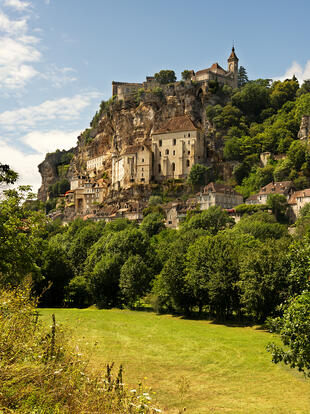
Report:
112,47,239,100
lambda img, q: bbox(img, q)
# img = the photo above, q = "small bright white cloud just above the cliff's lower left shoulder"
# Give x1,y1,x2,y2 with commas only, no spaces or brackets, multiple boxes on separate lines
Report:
22,130,81,154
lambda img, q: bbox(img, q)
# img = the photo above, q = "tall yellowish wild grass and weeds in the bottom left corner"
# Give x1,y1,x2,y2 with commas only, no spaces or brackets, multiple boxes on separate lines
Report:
0,284,160,414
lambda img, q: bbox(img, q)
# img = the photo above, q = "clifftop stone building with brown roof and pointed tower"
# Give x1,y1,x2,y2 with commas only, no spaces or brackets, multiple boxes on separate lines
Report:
191,47,239,88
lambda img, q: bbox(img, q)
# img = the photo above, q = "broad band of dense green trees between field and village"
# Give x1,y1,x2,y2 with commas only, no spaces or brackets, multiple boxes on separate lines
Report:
0,188,310,322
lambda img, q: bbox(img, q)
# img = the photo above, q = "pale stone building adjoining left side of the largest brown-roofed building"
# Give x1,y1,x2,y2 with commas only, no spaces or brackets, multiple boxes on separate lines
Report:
112,143,152,190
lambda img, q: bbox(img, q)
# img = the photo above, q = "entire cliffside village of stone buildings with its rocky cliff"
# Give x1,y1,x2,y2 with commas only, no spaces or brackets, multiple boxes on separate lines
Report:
39,48,310,228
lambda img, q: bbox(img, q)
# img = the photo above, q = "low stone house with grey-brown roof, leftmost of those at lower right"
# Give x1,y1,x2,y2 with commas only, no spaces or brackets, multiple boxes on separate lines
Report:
198,183,243,210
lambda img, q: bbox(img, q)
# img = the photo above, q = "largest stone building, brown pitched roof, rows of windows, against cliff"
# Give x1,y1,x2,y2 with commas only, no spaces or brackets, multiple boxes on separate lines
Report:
151,115,207,181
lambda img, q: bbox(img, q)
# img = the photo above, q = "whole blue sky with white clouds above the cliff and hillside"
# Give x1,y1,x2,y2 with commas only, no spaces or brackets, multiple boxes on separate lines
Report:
0,0,310,191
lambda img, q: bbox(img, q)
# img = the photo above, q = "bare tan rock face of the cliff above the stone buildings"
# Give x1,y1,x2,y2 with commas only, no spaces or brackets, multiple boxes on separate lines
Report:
38,81,225,201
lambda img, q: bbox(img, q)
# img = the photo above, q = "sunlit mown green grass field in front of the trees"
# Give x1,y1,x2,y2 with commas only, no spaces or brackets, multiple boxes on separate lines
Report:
40,309,310,414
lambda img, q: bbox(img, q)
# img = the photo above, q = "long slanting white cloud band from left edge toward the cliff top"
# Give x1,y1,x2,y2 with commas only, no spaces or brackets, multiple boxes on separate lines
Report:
0,92,100,131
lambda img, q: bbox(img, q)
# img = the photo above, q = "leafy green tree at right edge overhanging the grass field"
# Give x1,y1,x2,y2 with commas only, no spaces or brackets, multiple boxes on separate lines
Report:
267,291,310,377
